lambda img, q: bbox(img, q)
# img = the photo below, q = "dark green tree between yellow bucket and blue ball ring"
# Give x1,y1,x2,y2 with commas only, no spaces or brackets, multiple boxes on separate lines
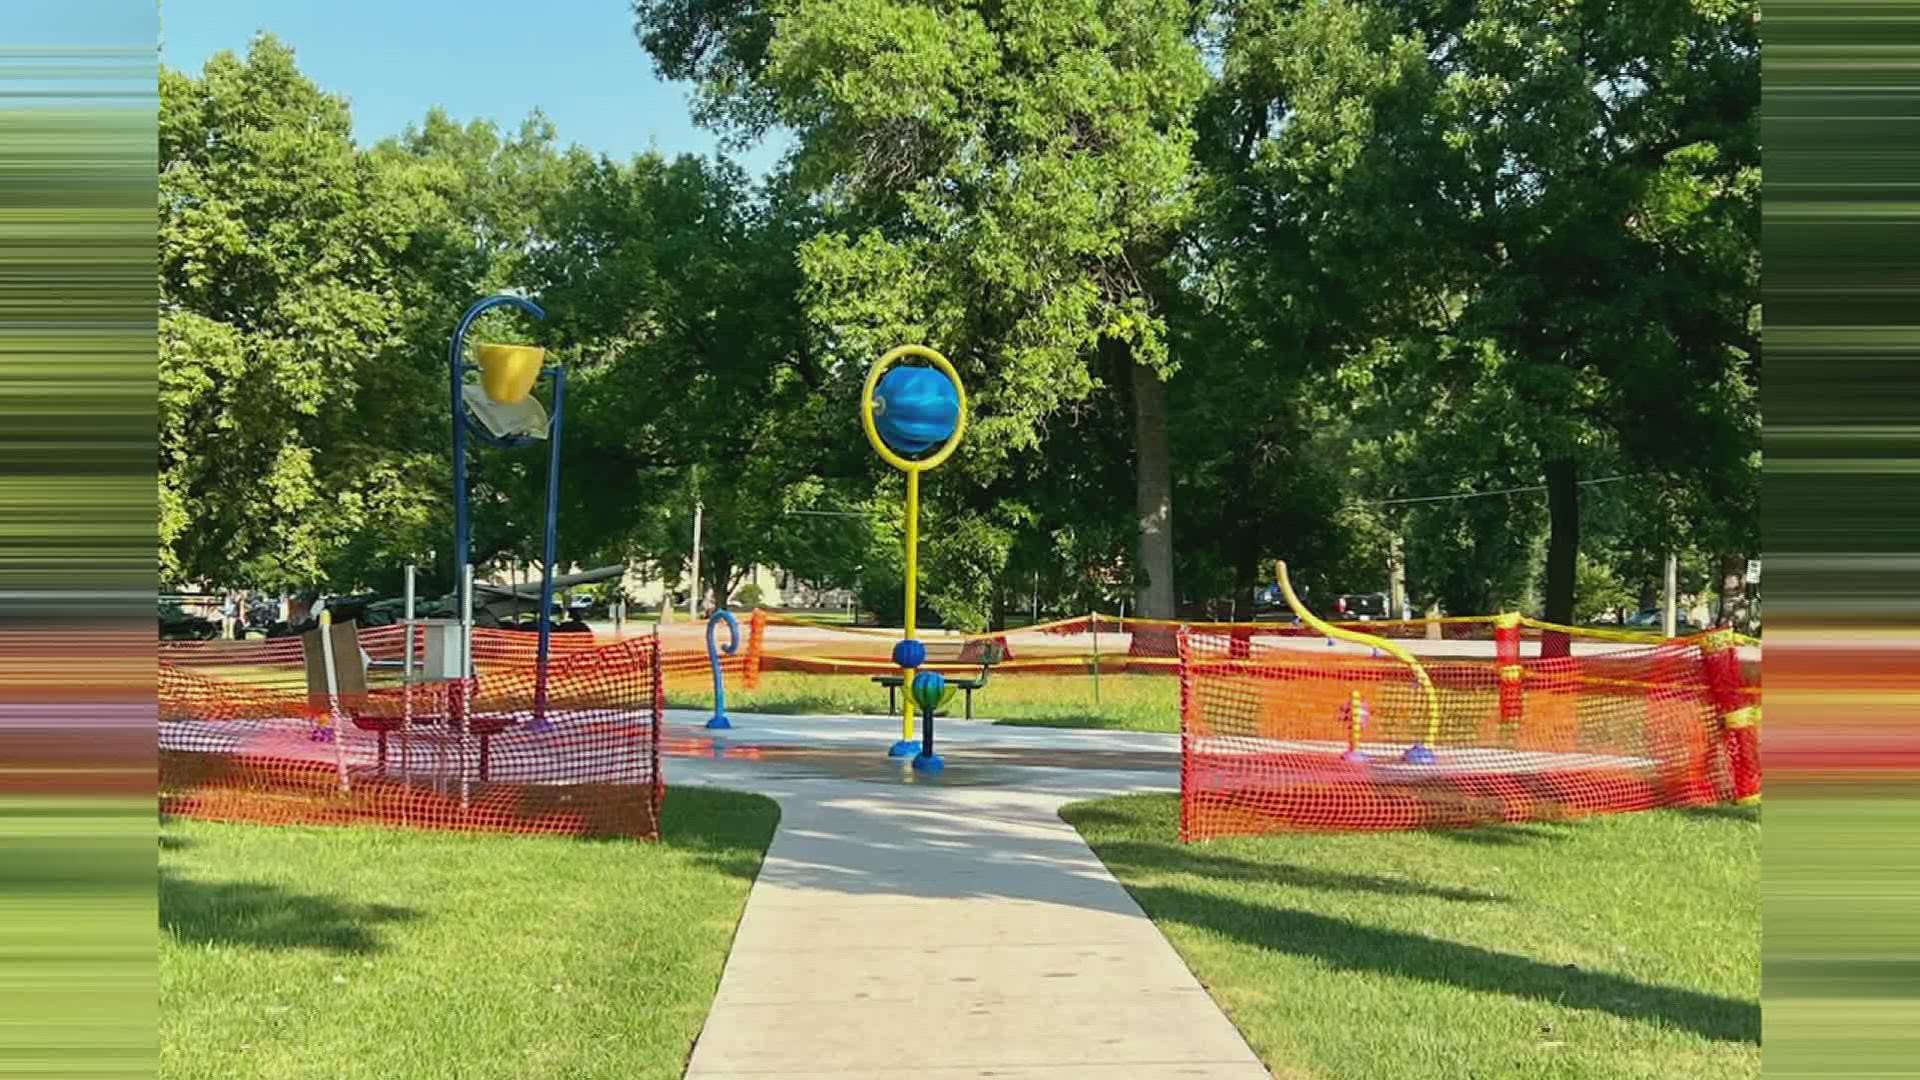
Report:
530,154,851,598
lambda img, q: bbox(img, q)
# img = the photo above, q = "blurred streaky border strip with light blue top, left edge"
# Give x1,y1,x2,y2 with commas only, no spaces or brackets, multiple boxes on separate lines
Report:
0,0,157,1076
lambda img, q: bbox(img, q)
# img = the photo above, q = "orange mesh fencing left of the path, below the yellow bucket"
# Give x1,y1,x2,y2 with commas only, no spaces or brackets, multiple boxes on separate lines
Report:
159,626,664,838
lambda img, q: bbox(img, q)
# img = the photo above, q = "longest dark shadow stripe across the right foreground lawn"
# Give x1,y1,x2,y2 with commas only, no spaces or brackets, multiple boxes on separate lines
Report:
1133,886,1761,1045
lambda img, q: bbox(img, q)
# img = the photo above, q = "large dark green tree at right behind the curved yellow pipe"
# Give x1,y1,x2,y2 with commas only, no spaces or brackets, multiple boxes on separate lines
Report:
1223,0,1759,638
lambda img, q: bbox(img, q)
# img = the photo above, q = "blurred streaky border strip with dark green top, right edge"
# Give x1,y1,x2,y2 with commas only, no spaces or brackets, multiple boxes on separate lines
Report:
1763,0,1920,1078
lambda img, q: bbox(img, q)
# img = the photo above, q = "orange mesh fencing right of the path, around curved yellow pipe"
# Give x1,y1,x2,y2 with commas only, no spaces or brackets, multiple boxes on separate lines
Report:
1177,626,1759,840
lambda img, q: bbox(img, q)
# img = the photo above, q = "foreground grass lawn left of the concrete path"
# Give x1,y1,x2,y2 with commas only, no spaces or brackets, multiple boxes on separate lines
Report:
159,788,780,1080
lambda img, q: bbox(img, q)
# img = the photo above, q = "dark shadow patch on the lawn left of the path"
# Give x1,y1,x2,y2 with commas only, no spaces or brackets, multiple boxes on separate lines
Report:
159,869,420,953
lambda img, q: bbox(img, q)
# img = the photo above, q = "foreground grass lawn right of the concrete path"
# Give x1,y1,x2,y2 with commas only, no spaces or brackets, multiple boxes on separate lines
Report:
1062,796,1761,1080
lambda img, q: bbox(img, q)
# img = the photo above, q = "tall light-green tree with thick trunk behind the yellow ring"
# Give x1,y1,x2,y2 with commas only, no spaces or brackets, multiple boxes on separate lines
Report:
636,0,1206,615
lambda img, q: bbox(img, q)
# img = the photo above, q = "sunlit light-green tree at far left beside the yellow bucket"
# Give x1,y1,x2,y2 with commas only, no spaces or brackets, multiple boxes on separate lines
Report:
159,37,420,588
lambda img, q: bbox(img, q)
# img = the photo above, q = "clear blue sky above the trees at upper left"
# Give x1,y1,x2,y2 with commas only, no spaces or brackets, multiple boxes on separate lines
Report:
145,0,783,175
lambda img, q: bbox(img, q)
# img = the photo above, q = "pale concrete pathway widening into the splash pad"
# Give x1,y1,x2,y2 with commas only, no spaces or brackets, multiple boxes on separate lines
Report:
666,713,1267,1080
